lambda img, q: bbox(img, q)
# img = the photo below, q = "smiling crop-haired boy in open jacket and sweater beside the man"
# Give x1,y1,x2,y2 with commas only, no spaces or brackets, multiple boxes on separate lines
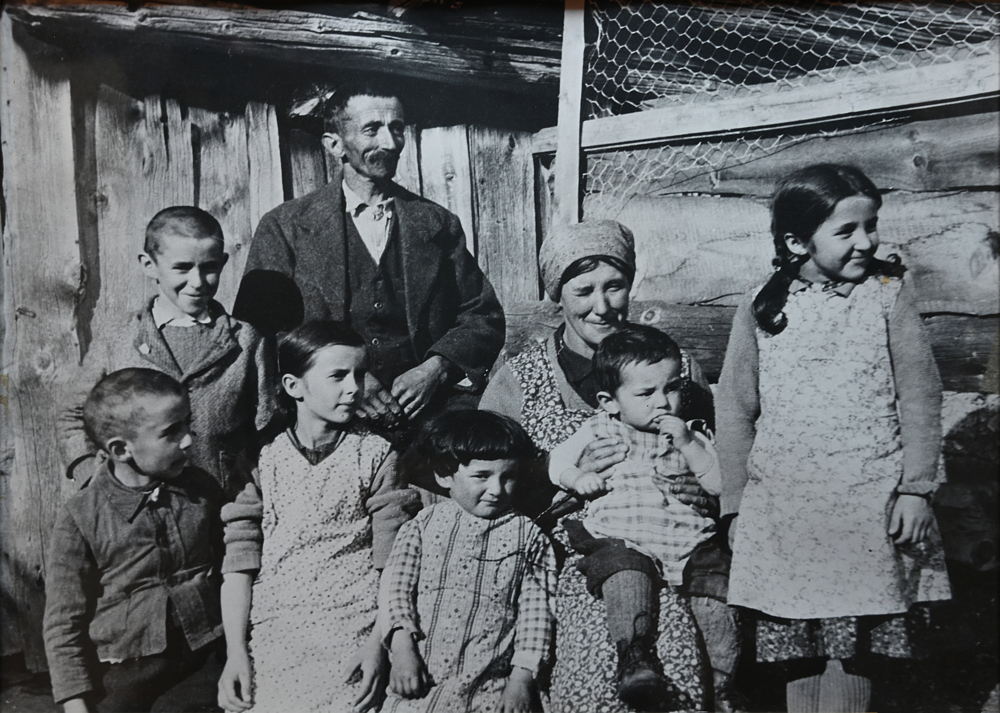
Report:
63,206,275,497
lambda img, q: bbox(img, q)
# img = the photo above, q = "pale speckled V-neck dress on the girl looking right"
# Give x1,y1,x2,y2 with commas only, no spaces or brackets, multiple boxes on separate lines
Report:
250,430,389,713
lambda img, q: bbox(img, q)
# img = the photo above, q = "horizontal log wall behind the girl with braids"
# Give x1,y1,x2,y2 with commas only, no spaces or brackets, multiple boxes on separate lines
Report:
584,112,1000,391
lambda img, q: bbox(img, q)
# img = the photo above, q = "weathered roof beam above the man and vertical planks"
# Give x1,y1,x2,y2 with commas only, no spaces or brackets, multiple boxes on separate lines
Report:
7,2,559,91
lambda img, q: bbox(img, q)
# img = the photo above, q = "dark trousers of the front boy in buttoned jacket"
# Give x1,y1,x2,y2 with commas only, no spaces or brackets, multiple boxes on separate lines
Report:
96,627,225,713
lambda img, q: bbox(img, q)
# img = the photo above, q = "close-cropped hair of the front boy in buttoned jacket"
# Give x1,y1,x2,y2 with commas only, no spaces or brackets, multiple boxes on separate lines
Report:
83,368,188,450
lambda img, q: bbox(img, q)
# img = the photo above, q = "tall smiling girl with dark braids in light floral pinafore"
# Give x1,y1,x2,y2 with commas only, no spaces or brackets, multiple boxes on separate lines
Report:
716,164,950,712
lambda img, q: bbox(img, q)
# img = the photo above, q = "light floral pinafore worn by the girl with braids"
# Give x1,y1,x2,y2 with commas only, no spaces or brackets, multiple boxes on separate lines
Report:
729,278,950,619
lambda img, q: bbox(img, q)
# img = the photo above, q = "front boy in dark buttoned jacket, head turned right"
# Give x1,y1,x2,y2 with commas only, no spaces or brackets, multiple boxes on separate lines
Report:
44,369,222,713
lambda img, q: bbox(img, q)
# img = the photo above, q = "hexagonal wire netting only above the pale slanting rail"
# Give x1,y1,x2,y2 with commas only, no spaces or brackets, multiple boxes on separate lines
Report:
584,0,1000,118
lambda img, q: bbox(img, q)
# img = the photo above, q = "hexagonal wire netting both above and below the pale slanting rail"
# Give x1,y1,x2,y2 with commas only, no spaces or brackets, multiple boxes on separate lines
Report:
582,0,1000,218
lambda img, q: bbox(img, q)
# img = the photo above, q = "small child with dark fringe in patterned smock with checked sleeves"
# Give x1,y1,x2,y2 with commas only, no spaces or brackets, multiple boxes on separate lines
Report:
379,411,556,713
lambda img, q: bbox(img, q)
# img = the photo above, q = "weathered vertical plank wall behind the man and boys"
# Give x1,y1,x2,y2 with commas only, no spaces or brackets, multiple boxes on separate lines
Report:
0,40,537,669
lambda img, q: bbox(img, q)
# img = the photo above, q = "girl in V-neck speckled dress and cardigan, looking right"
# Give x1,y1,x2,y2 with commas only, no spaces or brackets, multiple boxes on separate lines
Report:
219,322,419,713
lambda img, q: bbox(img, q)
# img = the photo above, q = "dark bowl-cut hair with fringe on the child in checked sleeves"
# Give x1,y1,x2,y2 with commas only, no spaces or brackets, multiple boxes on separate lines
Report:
399,410,538,483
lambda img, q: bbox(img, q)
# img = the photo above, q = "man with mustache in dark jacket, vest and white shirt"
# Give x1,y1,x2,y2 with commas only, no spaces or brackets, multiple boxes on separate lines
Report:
233,84,504,429
